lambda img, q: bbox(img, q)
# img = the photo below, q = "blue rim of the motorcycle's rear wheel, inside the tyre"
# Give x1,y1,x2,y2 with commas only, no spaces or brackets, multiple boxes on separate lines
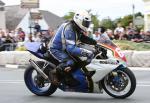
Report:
28,70,51,93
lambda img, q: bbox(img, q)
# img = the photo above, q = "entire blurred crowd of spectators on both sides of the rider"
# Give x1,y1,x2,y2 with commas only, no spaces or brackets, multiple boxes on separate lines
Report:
0,23,150,51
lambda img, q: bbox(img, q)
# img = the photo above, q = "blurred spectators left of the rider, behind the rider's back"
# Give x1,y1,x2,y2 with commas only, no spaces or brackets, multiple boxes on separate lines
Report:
0,28,54,51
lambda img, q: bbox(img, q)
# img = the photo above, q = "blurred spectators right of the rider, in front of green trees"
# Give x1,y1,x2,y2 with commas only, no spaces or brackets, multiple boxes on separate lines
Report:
88,23,150,42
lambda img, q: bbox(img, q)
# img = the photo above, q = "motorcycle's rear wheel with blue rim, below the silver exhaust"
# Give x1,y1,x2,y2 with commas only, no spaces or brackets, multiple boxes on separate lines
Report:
24,62,57,96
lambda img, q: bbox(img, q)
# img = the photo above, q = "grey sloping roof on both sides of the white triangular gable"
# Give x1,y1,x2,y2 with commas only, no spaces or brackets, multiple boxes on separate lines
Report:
5,5,64,30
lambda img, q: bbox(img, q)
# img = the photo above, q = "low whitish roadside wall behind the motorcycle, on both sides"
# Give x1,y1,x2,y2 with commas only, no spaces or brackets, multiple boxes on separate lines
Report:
0,51,150,67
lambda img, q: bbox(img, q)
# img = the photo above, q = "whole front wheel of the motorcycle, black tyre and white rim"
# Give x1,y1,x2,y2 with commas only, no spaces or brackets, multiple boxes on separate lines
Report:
102,68,136,99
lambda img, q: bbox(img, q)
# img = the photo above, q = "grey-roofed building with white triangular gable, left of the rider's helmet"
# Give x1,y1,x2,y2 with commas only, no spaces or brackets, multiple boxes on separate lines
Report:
0,1,64,33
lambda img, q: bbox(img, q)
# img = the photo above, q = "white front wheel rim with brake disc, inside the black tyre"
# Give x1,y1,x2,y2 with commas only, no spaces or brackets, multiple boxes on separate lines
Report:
104,70,131,96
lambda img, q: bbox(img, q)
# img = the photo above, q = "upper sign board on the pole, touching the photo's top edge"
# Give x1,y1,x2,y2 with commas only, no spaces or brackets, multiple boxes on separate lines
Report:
21,0,39,8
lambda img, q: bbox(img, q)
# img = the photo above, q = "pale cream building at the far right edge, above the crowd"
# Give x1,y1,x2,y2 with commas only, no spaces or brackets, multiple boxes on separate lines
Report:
143,0,150,31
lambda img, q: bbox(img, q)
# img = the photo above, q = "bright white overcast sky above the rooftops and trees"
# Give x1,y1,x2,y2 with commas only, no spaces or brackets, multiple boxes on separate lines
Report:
1,0,144,19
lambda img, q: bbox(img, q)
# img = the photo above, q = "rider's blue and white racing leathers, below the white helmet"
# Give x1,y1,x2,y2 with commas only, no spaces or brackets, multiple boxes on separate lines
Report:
50,21,97,73
